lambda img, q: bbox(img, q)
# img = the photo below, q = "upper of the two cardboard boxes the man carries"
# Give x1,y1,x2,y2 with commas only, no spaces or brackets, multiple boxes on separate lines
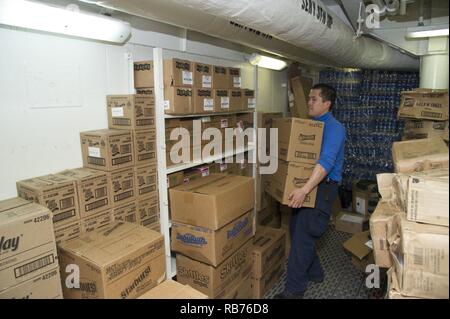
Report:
273,118,323,164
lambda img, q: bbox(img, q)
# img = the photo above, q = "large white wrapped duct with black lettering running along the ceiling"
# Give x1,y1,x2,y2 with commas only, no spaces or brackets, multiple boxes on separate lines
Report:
84,0,419,70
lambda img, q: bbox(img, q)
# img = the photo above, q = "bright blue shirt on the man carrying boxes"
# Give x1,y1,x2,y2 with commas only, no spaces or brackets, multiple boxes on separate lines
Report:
314,112,345,182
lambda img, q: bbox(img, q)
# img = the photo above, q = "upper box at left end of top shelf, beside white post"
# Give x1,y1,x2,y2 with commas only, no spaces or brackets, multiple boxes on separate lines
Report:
164,59,194,88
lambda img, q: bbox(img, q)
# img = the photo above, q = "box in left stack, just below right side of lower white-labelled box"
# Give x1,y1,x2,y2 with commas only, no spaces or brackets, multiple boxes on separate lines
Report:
109,167,136,208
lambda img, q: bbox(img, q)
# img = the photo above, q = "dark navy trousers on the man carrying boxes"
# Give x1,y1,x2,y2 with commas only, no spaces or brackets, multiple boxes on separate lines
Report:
286,182,338,294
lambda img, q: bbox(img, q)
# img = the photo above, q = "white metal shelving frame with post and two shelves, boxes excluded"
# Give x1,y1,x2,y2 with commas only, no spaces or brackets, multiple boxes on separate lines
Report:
153,48,258,278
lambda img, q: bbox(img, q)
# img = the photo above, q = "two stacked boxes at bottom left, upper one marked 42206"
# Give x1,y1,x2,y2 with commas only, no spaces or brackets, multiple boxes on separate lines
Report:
0,198,62,299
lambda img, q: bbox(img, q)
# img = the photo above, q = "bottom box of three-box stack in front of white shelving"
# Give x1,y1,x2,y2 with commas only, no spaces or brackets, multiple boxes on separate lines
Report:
177,240,252,298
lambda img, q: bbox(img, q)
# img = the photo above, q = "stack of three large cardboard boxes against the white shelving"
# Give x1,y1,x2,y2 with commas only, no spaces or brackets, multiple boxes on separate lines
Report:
169,174,254,298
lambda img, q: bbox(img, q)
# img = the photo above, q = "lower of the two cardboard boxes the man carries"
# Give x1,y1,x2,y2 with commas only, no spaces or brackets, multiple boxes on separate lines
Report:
266,158,317,207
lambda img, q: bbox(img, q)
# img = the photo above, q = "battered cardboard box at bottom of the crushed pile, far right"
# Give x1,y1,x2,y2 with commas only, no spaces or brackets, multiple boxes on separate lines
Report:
390,214,449,299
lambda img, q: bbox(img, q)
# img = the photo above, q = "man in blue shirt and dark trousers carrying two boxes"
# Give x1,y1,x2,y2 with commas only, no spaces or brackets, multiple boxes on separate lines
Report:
275,84,345,299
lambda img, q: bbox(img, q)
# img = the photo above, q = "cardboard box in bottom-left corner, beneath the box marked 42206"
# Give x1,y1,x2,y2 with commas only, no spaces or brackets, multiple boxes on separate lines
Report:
0,266,62,299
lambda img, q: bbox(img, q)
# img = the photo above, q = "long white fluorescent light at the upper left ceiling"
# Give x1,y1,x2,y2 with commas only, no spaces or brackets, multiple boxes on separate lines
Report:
0,0,131,43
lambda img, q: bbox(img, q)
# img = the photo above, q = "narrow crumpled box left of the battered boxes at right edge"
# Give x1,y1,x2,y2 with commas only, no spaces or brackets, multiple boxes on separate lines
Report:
369,200,404,268
